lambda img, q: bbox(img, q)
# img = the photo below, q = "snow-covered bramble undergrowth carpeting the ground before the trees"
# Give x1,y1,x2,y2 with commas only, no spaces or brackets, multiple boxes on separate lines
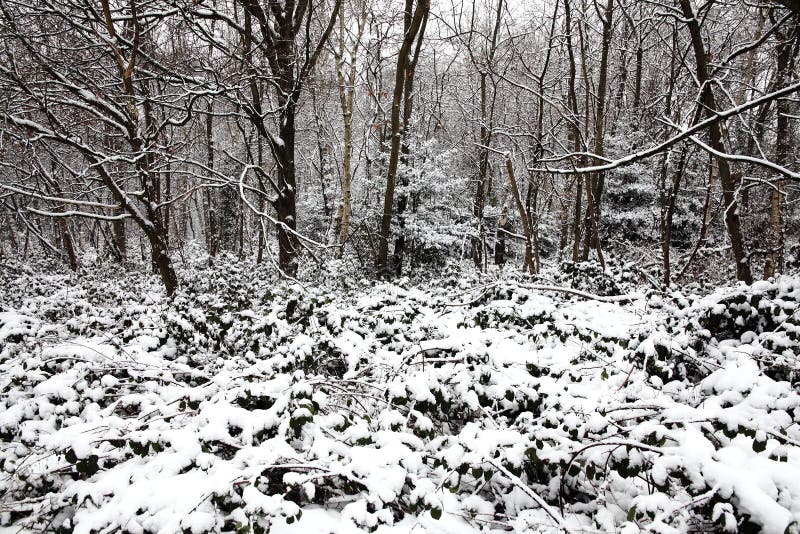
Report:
0,262,800,534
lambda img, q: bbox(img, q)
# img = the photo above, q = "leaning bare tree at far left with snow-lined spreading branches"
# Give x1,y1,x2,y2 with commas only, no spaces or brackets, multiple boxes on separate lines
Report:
0,0,178,295
